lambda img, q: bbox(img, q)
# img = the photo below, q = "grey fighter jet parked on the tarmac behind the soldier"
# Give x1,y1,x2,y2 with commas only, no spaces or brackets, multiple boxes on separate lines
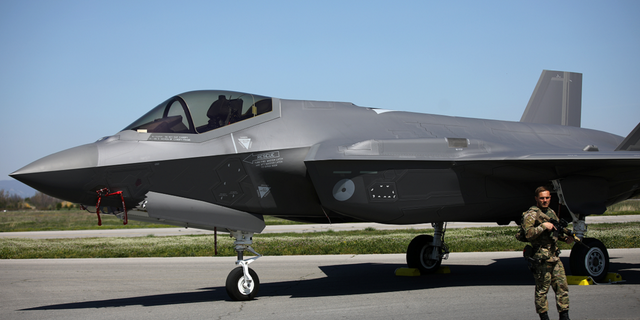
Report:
11,70,640,300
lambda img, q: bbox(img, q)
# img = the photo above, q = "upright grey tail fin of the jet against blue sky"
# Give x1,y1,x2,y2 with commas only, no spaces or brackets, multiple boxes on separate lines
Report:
520,70,582,127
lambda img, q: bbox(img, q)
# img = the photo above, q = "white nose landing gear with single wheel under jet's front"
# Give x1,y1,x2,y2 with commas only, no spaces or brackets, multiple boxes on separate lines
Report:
226,231,262,301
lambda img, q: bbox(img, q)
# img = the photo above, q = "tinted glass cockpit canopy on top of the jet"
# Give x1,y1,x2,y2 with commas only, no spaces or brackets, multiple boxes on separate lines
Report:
123,90,272,133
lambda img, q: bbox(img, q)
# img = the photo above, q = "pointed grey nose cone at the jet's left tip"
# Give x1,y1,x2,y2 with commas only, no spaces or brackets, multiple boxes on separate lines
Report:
10,143,98,202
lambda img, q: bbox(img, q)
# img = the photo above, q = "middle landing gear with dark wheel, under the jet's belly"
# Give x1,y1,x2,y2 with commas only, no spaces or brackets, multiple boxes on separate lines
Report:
407,222,449,274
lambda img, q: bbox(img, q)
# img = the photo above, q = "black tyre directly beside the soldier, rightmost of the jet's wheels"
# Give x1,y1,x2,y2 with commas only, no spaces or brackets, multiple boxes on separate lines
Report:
570,238,609,282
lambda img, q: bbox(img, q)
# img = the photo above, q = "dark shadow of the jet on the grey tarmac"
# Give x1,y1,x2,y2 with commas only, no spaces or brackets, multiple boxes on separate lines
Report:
20,258,640,311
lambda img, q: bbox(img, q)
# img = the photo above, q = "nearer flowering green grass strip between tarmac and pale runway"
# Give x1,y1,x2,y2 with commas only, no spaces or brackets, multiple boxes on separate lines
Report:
0,222,640,259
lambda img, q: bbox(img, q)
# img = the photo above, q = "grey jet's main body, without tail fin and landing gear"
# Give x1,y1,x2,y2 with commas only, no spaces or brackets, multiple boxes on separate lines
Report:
12,91,638,227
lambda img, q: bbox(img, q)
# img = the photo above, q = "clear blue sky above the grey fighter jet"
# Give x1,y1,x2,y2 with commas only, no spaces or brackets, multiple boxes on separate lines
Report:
0,0,640,180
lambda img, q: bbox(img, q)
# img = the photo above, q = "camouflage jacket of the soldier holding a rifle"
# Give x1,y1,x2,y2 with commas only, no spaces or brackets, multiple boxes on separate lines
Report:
522,206,560,262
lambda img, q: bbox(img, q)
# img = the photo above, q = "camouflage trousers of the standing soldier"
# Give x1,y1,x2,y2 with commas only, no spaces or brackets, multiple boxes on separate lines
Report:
533,261,569,313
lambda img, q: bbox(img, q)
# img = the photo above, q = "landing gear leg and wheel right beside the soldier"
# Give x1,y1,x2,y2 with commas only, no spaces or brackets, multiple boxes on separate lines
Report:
552,180,609,282
